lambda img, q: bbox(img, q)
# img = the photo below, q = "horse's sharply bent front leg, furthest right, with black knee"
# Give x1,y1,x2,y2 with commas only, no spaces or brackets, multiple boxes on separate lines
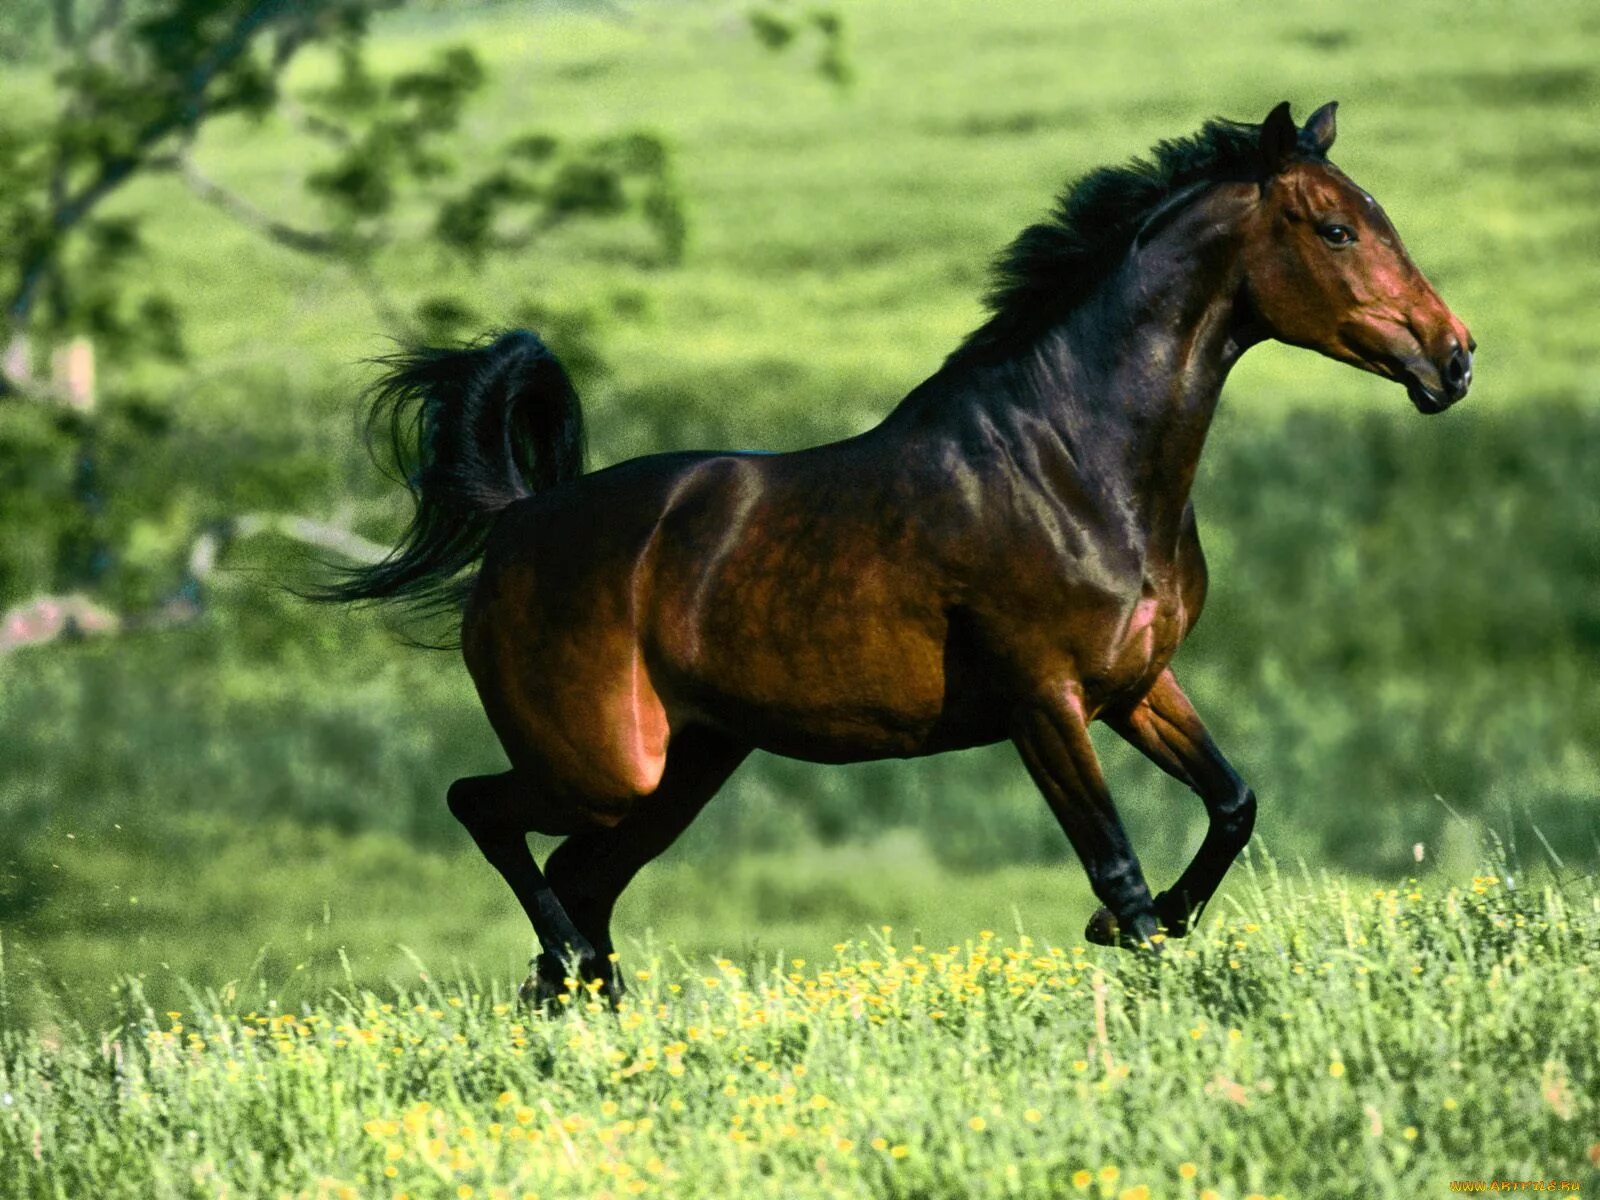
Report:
1106,670,1256,938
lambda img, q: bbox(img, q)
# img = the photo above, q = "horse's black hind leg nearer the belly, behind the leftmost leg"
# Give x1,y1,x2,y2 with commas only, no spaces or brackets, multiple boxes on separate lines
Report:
546,728,750,997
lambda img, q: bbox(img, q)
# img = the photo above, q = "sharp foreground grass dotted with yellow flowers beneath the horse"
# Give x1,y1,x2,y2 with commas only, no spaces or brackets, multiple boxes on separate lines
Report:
0,862,1600,1200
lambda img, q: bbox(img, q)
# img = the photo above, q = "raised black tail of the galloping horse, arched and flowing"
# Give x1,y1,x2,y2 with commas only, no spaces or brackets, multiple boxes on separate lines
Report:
312,330,584,624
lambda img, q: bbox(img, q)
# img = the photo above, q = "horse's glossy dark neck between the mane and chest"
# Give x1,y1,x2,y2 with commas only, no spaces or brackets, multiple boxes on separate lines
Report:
984,206,1251,536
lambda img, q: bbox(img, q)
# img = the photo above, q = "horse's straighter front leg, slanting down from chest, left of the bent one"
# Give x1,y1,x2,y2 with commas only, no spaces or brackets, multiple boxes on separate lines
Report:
1013,685,1158,949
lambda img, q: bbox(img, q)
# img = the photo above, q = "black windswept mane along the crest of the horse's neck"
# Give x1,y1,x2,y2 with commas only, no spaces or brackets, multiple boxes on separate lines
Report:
950,118,1312,360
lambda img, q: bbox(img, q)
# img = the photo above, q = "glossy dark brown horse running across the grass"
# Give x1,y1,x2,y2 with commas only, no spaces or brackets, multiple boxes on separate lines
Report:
328,102,1475,994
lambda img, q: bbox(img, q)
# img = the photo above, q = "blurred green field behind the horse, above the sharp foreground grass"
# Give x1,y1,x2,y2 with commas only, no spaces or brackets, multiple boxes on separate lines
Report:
0,0,1600,1019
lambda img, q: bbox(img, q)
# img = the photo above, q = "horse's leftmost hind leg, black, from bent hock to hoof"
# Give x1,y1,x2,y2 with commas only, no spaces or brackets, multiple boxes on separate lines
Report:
446,771,595,1000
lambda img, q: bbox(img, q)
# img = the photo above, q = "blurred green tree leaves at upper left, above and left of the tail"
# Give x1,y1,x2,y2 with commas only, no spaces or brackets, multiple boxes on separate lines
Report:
0,0,700,598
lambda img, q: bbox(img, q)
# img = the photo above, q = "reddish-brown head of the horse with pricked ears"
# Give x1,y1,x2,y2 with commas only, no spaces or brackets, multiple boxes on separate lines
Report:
1245,101,1477,413
